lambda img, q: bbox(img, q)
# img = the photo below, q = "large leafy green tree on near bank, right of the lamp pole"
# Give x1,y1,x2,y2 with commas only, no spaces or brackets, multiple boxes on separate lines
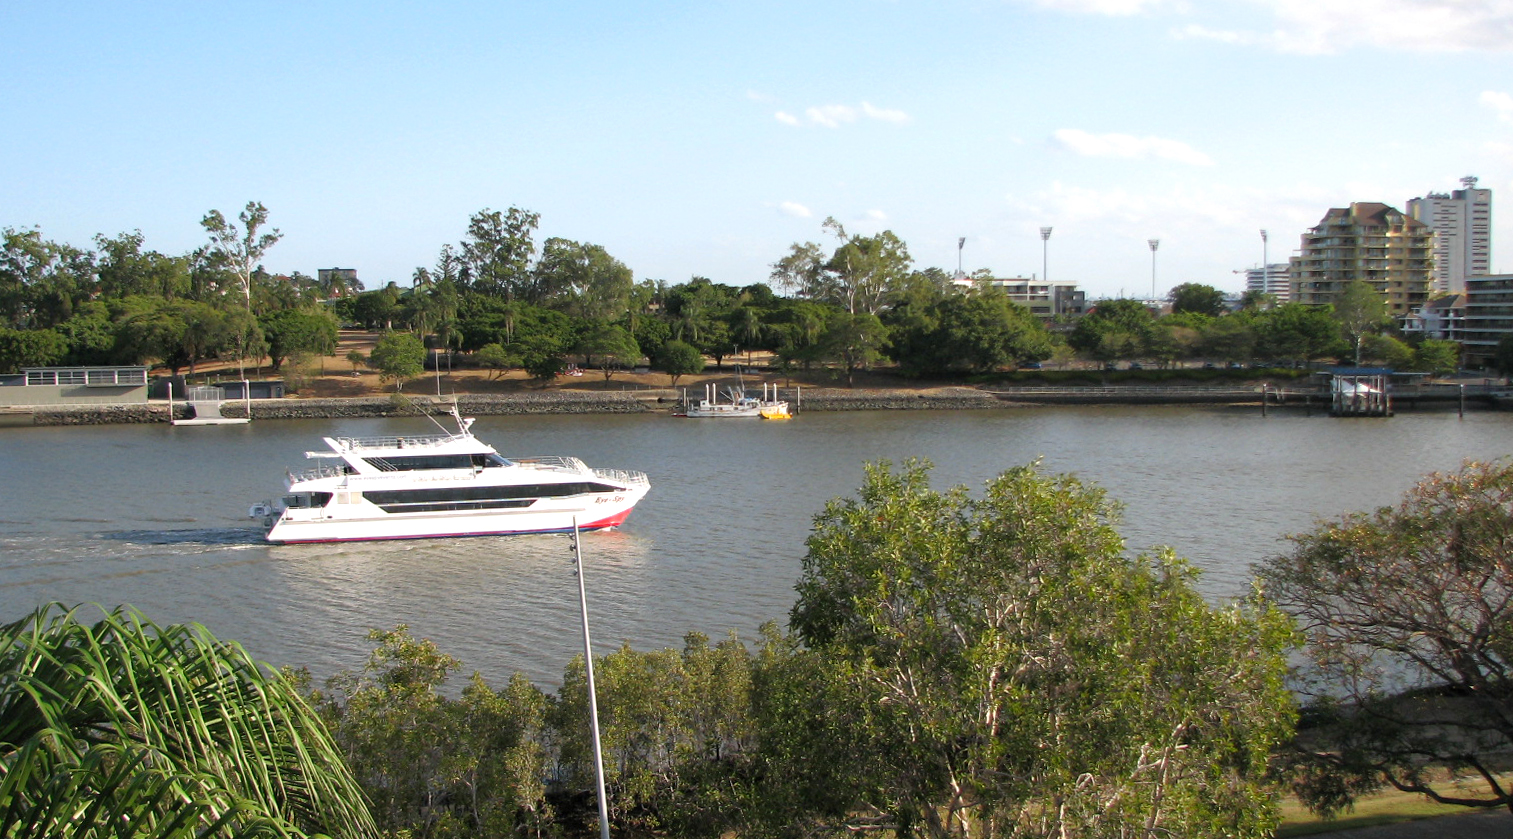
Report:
785,463,1294,839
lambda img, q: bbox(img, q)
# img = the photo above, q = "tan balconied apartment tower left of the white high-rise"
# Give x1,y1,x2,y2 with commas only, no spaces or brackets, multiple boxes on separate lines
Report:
1288,201,1434,317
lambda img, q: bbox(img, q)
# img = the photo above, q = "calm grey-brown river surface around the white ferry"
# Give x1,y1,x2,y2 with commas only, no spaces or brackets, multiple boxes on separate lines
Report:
0,407,1513,688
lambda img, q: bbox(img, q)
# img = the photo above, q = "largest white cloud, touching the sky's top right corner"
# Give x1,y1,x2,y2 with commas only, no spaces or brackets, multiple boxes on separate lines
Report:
1173,0,1513,54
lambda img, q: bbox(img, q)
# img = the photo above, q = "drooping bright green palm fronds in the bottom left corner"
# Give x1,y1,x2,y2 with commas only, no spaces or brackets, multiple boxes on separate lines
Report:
0,603,378,839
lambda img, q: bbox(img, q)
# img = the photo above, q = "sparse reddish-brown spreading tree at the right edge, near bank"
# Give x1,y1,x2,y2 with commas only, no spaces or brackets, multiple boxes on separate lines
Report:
1260,461,1513,812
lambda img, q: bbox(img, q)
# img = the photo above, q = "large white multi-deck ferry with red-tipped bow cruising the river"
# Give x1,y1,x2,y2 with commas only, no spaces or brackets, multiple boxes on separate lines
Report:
248,407,651,543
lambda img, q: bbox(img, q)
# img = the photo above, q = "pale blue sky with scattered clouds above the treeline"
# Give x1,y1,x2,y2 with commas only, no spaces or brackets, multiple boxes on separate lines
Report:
0,0,1513,299
